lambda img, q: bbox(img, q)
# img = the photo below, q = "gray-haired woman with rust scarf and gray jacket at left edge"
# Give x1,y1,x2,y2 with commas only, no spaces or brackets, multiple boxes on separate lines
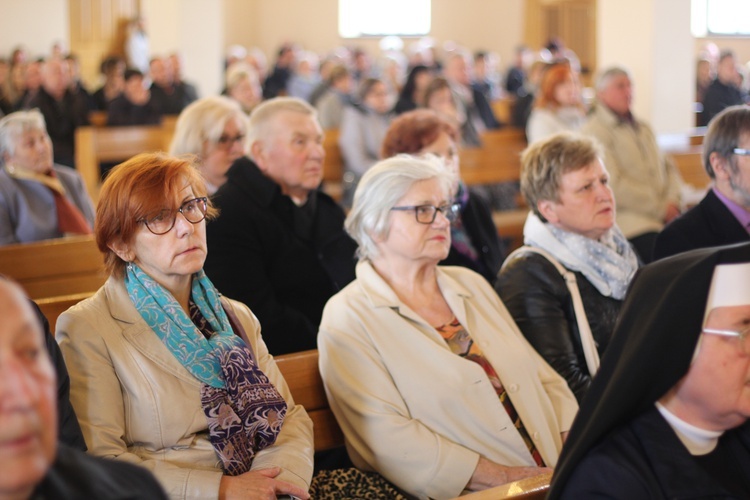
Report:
0,109,94,245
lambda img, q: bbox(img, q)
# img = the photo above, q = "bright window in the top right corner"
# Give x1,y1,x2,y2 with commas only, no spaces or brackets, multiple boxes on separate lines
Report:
691,0,750,37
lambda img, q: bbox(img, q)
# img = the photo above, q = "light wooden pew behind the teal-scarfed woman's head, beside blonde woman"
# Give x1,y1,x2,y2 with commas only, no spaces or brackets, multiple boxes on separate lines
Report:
75,126,172,203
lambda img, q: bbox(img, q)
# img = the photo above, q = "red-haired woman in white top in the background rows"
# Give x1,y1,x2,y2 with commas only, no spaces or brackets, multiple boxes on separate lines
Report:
526,63,586,143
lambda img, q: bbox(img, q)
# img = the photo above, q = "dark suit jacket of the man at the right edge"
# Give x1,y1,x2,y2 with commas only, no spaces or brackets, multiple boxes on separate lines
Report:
654,189,750,259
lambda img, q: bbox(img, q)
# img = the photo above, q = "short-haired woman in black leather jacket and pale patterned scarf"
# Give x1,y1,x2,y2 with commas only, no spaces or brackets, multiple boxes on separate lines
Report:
495,133,638,402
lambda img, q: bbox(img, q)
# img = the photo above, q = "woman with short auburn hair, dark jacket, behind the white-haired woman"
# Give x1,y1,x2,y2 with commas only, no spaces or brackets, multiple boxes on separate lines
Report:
381,109,505,283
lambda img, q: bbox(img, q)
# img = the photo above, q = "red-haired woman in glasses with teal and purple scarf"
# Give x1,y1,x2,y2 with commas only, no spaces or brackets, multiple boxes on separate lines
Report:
56,154,313,498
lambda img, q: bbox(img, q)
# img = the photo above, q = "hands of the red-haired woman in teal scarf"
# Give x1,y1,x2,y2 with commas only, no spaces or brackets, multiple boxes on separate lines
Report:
219,467,310,500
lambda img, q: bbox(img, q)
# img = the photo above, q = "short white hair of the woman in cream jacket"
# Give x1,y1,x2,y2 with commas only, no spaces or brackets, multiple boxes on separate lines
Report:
344,155,455,260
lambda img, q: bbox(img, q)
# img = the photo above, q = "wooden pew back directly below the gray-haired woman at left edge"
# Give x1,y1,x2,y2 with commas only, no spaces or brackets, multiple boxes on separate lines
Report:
0,235,107,299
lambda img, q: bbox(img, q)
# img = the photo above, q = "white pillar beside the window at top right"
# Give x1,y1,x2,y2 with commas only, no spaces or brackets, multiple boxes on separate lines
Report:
597,0,695,133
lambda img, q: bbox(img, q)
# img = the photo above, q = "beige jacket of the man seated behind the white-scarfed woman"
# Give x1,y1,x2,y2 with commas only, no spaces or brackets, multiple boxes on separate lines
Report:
583,105,682,238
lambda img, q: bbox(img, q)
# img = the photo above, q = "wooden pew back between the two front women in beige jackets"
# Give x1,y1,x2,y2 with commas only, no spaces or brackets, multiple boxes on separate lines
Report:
275,350,344,451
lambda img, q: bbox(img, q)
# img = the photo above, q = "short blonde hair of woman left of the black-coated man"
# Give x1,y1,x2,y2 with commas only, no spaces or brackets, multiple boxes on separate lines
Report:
169,96,247,156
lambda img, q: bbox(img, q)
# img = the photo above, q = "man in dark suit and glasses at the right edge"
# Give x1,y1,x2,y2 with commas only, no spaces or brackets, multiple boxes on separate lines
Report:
654,106,750,259
